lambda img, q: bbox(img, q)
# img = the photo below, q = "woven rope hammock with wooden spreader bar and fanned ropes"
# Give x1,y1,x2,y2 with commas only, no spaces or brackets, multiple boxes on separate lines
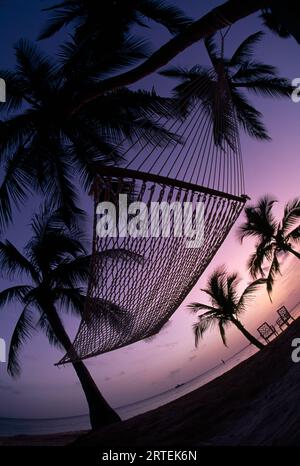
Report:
59,66,247,364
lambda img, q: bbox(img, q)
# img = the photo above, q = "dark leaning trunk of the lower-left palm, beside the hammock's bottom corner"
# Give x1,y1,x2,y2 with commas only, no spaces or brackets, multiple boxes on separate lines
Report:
47,304,121,430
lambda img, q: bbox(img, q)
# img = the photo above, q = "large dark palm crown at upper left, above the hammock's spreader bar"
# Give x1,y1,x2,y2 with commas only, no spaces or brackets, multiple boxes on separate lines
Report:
0,41,172,232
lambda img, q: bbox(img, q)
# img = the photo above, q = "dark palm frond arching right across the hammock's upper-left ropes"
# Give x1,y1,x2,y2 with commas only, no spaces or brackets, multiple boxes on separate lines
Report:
78,89,180,147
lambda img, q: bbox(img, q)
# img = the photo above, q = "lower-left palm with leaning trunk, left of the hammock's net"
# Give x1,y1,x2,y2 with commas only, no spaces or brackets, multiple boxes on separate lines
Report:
0,207,135,429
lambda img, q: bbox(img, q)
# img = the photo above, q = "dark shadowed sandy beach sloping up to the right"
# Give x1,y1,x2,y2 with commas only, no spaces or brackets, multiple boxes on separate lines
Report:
0,319,300,447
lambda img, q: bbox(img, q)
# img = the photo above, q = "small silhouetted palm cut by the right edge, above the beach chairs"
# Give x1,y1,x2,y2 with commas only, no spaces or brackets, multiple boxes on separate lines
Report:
238,196,300,294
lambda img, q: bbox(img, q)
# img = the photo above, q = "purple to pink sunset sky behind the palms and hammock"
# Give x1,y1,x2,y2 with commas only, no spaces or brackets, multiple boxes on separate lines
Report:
0,0,300,418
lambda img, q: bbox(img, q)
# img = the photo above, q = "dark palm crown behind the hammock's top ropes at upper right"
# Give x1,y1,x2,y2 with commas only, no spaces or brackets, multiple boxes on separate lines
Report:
161,32,292,144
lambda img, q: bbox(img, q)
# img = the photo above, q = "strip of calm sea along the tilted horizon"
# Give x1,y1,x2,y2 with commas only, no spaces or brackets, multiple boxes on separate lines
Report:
0,303,300,437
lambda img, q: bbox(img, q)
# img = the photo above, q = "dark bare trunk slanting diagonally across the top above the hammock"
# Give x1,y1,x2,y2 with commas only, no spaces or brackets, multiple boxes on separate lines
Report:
70,0,272,114
